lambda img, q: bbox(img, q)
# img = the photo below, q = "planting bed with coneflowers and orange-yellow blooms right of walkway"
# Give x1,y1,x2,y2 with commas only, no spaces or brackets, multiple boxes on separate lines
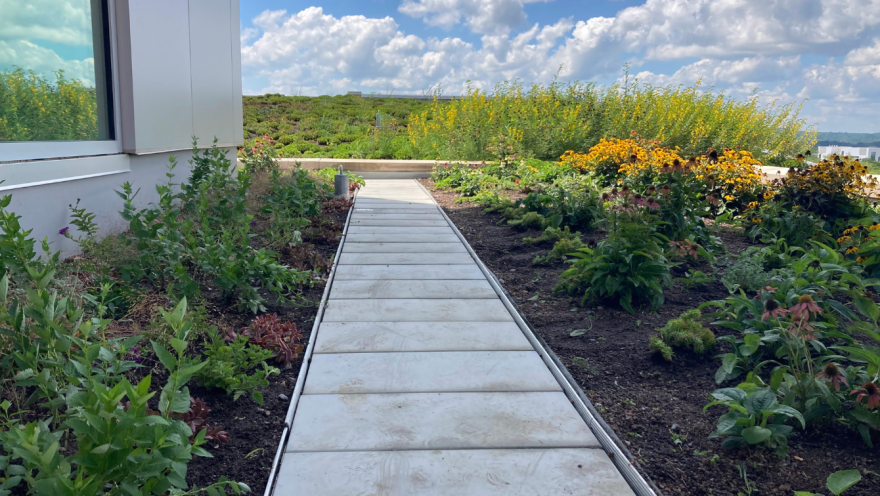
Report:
432,133,880,494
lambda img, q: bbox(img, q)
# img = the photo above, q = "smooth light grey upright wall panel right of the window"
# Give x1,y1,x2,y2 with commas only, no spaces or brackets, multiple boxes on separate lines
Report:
115,0,244,154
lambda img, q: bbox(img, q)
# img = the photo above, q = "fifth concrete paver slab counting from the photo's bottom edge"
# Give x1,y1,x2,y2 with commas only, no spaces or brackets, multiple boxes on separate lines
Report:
324,299,513,322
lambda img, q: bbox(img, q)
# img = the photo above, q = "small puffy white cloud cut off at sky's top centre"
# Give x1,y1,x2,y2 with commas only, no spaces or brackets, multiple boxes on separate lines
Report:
398,0,553,34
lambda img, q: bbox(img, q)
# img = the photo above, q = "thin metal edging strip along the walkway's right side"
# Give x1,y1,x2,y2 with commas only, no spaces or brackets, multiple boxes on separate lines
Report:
414,181,662,496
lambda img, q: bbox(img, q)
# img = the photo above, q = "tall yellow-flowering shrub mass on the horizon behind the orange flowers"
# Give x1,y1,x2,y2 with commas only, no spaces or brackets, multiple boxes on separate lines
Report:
409,81,816,160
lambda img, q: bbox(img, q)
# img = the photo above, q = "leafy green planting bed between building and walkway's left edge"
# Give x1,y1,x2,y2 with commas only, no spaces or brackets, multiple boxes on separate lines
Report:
0,139,351,495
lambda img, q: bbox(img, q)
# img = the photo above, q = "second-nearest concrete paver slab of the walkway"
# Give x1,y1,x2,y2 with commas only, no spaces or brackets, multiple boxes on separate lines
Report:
287,392,599,452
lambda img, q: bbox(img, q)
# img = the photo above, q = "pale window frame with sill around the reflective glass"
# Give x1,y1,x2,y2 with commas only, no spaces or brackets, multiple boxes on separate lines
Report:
0,0,122,165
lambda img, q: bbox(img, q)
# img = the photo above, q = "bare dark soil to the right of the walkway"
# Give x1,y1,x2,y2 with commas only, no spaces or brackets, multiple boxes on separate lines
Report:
422,180,880,496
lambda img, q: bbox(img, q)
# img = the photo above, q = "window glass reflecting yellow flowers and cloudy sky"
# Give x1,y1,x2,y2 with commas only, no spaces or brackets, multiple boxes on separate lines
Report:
0,0,114,142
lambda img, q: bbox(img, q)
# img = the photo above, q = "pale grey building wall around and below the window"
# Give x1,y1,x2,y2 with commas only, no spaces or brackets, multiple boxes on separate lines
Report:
0,0,244,256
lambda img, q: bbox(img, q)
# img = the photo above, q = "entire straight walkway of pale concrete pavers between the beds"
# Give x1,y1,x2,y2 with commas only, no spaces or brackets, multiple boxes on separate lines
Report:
275,180,633,496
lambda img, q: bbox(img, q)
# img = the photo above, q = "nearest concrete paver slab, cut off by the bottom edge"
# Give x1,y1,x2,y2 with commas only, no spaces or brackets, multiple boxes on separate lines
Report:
275,448,633,496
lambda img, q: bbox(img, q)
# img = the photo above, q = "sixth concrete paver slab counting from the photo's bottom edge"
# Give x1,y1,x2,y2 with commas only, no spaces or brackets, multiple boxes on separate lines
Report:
330,280,498,300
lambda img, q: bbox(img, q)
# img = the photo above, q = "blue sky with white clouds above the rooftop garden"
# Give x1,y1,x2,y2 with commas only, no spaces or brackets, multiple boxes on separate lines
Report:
241,0,880,132
